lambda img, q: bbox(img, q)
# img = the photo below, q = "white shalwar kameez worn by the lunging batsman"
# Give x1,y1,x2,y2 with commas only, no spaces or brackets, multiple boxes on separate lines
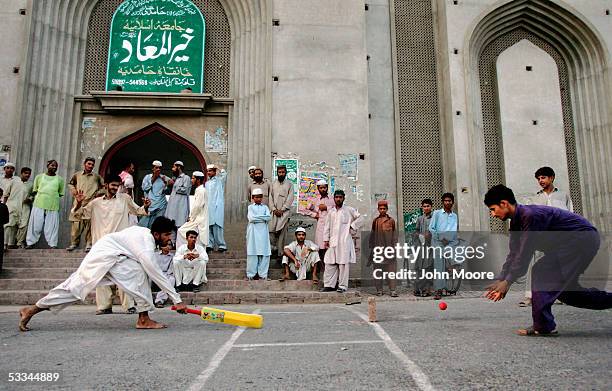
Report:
36,226,181,313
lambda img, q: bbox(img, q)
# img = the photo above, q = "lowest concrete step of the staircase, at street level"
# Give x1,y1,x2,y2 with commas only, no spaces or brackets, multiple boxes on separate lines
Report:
0,290,361,312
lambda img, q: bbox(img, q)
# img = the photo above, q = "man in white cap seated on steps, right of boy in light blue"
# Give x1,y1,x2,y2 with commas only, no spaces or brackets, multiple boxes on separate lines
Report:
281,227,321,284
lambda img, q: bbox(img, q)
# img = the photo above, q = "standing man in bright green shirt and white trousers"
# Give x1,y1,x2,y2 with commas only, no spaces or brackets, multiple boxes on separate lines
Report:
26,160,65,248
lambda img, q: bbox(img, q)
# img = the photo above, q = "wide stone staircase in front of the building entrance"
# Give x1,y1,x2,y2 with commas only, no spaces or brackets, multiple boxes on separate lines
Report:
0,249,360,305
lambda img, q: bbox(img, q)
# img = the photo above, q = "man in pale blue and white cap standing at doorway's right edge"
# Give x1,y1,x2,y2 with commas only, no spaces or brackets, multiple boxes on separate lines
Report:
206,164,227,252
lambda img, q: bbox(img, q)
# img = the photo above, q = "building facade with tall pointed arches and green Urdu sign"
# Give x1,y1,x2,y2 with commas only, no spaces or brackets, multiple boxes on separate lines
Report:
0,0,612,247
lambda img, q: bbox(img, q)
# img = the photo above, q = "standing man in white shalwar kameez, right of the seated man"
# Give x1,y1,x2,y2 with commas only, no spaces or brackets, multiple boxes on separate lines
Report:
324,205,363,290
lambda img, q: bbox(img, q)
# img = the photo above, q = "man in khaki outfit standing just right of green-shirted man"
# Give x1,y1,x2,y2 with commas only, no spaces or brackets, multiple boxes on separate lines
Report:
66,157,104,251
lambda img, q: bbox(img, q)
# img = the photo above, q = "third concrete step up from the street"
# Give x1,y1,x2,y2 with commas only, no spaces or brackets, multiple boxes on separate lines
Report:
0,264,282,280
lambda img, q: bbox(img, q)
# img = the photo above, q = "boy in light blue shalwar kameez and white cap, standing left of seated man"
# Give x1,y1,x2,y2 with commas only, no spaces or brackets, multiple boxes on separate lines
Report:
246,189,271,280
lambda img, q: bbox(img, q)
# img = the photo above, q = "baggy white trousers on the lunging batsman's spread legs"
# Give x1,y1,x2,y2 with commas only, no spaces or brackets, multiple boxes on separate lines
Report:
36,258,153,313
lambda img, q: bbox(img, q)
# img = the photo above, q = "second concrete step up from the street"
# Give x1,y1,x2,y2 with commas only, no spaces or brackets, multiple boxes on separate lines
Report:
0,278,318,291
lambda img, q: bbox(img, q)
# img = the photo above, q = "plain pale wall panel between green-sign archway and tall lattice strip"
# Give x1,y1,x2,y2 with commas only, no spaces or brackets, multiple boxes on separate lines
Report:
268,0,370,213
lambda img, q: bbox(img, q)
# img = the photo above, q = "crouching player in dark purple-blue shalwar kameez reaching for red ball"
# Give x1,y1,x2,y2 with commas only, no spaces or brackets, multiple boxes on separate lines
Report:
485,185,612,335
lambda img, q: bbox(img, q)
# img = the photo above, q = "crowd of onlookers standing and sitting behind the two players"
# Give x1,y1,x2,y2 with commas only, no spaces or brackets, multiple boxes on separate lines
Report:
0,158,572,313
